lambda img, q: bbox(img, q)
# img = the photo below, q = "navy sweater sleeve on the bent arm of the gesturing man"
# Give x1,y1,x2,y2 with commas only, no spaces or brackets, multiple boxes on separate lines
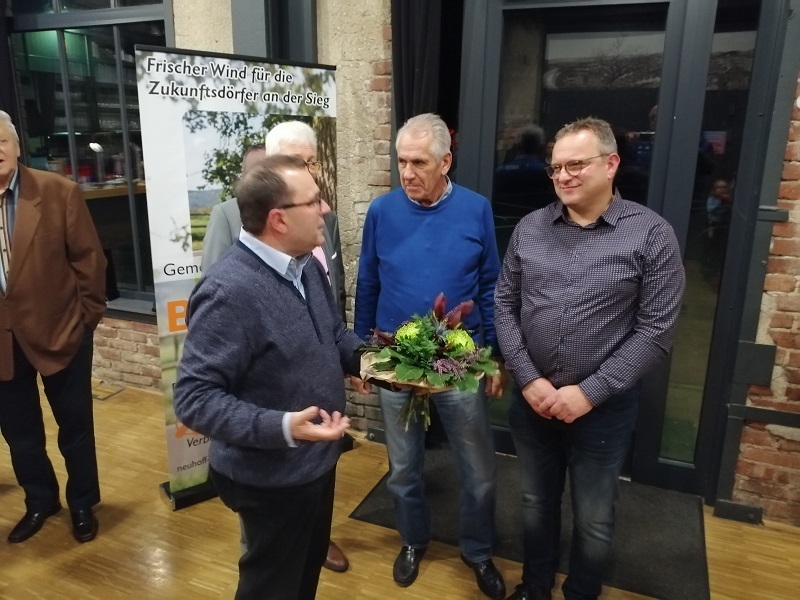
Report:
174,279,288,449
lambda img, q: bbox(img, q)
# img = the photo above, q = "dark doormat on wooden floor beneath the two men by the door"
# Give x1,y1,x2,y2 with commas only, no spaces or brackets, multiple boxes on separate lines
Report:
350,448,709,600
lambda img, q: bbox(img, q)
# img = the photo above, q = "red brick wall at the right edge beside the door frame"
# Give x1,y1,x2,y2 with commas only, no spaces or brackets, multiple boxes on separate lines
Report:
733,80,800,525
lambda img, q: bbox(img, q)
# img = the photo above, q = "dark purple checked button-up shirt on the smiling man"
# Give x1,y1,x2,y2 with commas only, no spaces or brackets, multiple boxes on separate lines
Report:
495,193,685,406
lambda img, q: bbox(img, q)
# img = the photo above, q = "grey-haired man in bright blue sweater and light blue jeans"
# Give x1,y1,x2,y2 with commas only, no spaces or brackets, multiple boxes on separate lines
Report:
354,114,505,598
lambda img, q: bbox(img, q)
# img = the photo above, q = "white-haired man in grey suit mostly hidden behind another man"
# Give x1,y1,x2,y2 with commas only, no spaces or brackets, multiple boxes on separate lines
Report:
202,121,350,573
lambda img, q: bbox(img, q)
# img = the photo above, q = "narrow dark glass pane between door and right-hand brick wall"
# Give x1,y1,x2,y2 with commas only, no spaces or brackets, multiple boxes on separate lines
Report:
660,1,758,462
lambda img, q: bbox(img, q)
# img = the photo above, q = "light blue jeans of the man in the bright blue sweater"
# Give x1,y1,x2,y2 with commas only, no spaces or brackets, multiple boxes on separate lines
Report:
378,385,497,562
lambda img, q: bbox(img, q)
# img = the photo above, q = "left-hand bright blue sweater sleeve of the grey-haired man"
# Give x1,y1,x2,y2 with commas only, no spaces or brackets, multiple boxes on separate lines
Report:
353,200,381,339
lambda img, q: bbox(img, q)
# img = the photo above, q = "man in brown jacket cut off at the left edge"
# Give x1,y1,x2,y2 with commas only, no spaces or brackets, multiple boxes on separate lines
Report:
0,111,106,544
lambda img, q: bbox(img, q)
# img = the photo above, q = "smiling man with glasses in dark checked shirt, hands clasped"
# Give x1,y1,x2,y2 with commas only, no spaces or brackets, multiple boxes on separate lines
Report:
495,118,685,600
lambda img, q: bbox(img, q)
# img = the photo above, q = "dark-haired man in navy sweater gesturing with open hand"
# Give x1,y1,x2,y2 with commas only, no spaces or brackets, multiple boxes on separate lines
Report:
175,155,361,600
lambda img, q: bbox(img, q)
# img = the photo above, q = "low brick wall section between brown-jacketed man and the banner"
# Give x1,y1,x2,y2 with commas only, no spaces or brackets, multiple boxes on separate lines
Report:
92,317,161,392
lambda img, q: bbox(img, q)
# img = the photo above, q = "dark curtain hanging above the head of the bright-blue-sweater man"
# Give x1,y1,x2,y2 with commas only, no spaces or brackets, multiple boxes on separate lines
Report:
392,0,442,127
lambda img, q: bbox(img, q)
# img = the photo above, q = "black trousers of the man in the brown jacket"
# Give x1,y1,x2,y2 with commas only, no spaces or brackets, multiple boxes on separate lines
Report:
0,330,100,511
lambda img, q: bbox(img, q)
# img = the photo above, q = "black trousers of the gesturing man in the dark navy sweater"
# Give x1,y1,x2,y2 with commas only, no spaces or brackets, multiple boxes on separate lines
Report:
211,469,336,600
